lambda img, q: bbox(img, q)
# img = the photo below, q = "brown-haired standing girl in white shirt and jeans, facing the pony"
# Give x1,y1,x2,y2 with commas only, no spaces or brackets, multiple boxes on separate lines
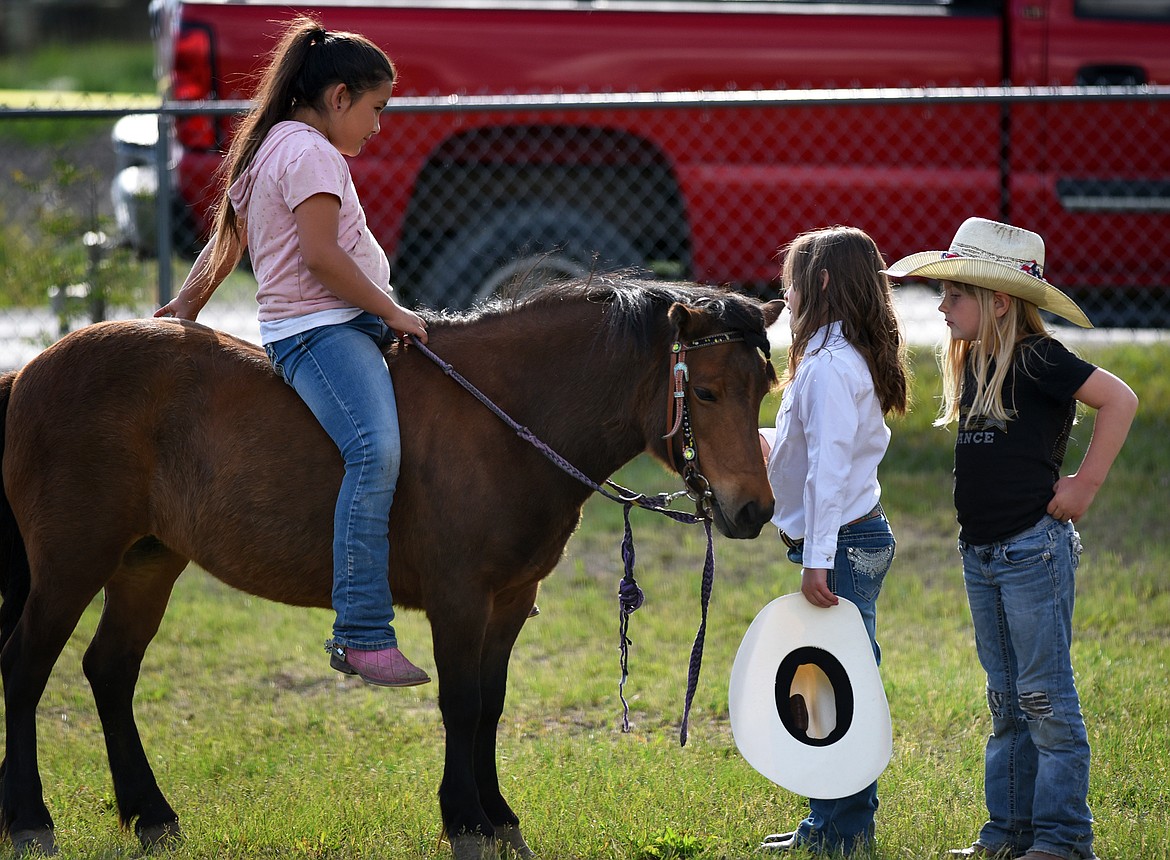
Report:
761,227,909,855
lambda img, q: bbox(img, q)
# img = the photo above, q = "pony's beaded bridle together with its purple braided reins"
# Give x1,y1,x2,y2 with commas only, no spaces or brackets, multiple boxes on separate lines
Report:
408,331,744,747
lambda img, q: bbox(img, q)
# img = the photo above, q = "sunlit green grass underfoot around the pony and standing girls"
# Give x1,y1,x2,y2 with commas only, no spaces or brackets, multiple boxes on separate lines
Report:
16,344,1170,860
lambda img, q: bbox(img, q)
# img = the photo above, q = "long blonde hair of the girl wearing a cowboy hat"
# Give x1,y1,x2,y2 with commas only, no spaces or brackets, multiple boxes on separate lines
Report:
935,281,1051,427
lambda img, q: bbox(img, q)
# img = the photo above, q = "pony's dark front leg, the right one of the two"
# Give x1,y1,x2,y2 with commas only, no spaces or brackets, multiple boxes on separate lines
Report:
475,587,536,859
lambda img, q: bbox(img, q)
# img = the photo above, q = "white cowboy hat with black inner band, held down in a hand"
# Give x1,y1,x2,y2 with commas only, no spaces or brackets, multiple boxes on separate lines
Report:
728,592,894,799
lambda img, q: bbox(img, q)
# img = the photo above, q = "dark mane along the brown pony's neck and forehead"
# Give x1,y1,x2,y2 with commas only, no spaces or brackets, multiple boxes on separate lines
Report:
429,275,771,357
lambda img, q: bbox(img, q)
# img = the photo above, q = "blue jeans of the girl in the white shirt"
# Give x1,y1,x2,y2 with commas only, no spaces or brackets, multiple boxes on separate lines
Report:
797,516,896,854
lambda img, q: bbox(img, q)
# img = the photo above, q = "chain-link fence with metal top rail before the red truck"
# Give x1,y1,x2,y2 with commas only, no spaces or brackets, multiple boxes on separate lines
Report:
0,87,1170,369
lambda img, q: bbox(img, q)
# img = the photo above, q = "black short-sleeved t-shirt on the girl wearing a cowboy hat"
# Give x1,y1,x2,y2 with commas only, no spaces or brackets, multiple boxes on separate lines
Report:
955,335,1096,545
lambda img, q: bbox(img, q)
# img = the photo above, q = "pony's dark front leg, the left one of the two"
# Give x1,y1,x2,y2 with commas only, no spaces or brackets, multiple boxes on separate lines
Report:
428,599,496,860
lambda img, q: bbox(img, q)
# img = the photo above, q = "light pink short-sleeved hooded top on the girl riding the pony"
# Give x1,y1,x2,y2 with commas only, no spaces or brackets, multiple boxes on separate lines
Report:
228,121,391,323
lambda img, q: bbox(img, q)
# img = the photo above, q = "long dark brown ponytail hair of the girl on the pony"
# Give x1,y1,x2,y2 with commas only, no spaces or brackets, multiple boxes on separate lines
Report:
211,15,397,271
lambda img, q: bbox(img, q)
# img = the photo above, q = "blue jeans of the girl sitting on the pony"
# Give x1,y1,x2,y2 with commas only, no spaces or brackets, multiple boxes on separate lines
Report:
264,314,402,651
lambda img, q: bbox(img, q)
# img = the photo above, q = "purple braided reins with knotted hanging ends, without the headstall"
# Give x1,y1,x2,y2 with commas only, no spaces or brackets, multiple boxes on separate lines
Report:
407,336,715,747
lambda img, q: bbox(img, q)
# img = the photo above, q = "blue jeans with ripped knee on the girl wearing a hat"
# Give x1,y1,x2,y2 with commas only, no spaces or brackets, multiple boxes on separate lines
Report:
958,515,1093,860
